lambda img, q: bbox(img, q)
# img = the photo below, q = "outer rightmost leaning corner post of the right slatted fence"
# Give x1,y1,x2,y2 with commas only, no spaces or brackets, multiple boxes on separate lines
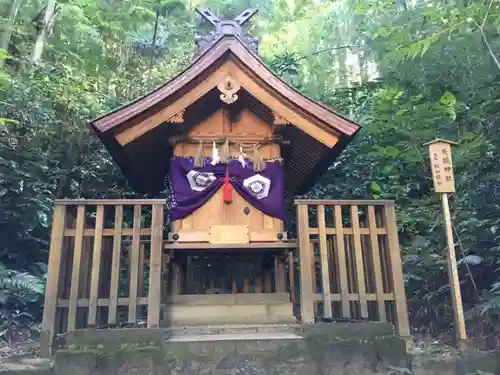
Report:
385,205,410,337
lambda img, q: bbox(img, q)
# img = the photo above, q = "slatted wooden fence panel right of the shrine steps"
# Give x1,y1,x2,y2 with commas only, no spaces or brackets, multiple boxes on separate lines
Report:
295,200,409,336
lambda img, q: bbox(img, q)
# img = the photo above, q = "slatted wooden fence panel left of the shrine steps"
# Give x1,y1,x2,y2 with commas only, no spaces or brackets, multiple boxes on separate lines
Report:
41,200,165,355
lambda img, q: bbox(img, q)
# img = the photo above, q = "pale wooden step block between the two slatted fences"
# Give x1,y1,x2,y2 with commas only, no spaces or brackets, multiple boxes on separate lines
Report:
161,293,296,327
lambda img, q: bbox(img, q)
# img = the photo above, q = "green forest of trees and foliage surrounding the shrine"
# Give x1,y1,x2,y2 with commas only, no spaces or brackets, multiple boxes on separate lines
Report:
0,0,500,346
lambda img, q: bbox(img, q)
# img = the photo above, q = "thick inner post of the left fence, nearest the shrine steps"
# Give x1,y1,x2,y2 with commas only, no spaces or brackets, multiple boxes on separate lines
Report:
143,204,164,328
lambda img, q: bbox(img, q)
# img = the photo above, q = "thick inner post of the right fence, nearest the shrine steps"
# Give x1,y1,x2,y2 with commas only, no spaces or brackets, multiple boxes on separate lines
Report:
297,204,314,324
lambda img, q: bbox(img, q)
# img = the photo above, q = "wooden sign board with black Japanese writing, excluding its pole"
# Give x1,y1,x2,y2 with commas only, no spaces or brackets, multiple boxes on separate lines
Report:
427,139,455,193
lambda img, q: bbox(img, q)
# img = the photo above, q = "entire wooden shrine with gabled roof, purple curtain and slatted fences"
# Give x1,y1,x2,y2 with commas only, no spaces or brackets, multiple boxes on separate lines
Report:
43,9,408,353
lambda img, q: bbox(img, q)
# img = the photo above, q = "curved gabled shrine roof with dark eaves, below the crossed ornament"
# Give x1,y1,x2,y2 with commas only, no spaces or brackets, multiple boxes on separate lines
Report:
91,9,360,195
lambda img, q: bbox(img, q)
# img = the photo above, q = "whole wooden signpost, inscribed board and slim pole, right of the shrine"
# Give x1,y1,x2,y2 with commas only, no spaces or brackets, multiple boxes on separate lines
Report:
425,139,467,347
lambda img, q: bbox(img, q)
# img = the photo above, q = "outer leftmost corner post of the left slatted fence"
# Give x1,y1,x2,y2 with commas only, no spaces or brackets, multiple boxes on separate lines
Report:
40,205,66,357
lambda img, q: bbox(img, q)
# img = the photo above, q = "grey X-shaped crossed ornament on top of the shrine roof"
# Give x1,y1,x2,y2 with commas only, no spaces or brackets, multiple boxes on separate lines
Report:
196,8,258,56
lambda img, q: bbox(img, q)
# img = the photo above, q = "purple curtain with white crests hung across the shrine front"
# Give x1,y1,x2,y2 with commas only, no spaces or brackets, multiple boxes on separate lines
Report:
170,156,285,221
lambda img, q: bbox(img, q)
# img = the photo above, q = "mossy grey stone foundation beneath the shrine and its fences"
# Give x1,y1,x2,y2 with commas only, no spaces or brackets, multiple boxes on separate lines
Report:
0,323,500,375
